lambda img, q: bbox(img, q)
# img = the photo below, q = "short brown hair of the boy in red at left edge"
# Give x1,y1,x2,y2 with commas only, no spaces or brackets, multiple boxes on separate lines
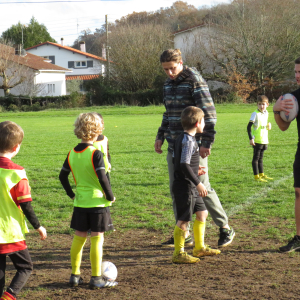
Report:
0,121,24,153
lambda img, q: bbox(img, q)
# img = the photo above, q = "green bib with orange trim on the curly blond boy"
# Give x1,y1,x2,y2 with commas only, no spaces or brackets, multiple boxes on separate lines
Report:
68,146,111,208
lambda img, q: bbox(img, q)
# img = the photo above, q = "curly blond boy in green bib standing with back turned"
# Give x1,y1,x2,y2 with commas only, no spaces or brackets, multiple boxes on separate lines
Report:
59,113,118,289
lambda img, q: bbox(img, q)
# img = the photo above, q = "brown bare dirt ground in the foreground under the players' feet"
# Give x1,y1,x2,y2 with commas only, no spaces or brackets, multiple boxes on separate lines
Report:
6,219,300,300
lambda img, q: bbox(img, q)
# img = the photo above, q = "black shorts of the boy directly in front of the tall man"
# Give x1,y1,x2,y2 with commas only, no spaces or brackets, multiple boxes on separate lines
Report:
172,180,206,222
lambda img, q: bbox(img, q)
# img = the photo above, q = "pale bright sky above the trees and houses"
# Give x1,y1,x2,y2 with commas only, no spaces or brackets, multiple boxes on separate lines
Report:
0,0,230,46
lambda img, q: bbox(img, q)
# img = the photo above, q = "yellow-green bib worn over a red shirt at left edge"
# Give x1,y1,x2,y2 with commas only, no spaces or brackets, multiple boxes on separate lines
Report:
0,168,28,244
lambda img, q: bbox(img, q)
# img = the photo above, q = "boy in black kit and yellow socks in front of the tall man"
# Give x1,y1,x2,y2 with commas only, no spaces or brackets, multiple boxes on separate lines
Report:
172,106,221,264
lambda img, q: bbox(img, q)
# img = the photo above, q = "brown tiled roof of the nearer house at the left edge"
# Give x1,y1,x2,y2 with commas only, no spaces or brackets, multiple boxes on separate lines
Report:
0,44,70,72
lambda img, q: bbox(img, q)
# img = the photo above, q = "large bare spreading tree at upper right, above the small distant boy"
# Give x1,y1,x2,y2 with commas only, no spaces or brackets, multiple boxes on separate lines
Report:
183,0,300,95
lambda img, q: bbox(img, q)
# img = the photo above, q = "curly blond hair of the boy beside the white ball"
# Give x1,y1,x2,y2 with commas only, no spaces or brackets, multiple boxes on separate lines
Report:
74,113,103,141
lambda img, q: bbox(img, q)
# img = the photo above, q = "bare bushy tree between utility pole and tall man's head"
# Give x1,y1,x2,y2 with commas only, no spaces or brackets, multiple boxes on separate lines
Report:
109,24,172,91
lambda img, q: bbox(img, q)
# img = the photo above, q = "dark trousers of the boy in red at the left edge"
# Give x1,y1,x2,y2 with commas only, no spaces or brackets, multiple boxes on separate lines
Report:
0,249,33,297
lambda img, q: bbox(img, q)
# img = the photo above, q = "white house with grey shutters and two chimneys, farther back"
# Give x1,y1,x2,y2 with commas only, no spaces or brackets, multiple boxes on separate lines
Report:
26,39,106,89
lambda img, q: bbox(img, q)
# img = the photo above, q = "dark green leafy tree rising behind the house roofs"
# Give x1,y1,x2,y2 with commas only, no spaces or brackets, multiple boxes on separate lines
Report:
1,17,56,48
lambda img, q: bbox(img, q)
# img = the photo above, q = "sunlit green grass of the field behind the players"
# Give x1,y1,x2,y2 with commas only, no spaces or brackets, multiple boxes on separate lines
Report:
0,104,297,237
